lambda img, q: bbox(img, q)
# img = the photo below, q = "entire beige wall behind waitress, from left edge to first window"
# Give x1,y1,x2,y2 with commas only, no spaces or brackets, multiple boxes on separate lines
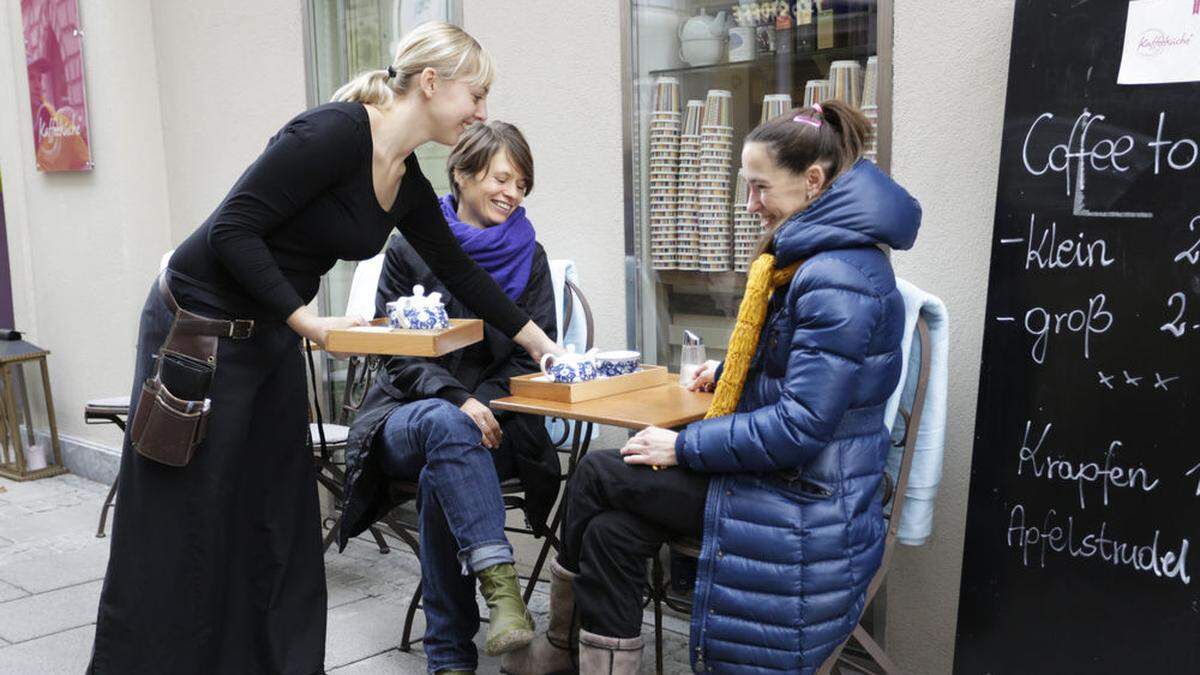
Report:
0,0,305,449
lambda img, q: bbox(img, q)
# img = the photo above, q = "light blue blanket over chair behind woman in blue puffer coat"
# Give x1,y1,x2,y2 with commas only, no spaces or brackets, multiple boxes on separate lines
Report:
884,279,950,546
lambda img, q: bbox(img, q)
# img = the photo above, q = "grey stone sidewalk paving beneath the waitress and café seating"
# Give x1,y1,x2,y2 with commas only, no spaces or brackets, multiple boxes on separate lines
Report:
0,474,690,675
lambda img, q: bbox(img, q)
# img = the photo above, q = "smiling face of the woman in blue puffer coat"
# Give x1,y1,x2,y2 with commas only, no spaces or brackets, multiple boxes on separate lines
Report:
742,142,826,229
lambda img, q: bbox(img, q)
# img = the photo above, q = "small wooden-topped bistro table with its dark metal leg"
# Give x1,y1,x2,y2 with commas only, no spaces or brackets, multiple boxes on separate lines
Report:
492,374,713,603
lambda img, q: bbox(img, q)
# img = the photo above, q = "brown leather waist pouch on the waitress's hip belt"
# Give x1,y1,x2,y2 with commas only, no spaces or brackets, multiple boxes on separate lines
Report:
130,276,236,466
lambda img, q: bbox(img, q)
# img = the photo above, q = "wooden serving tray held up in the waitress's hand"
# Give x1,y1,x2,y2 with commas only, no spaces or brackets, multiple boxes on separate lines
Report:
325,318,484,357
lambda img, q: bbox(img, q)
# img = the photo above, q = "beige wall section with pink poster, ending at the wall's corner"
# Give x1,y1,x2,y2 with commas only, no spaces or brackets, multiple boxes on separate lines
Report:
0,0,169,444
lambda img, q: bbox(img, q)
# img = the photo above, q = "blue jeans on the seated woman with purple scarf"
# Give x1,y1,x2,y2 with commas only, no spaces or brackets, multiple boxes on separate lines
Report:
377,399,512,673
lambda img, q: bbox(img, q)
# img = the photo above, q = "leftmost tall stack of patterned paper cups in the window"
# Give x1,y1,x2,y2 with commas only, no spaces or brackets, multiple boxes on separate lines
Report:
649,77,683,269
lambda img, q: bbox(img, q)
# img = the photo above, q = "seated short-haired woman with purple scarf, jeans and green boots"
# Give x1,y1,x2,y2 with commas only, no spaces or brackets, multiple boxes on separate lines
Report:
340,121,559,673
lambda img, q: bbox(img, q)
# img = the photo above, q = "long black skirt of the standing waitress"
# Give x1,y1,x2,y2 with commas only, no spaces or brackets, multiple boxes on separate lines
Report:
89,277,325,675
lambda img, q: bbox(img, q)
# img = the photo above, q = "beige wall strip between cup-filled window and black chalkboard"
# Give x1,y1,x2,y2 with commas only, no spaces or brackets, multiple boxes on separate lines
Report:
887,0,1013,674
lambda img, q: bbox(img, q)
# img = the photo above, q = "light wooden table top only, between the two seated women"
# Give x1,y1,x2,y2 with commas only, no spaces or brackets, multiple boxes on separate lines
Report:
492,378,713,430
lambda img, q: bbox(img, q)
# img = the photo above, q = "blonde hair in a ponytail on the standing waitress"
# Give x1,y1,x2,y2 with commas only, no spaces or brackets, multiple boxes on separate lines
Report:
332,22,496,107
